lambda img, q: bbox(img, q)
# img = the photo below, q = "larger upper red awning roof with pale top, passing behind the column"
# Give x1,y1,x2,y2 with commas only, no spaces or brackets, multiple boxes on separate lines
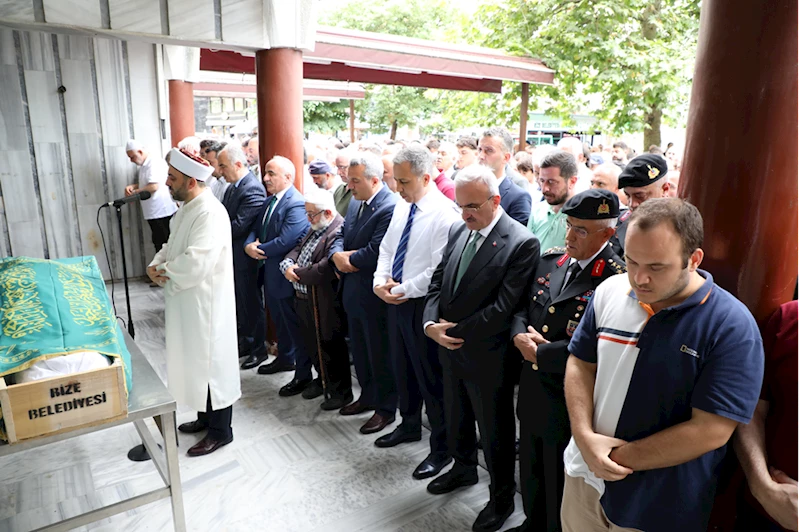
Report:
200,26,554,92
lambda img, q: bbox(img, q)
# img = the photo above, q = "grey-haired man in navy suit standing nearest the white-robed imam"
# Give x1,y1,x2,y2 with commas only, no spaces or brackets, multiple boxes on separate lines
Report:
217,142,266,357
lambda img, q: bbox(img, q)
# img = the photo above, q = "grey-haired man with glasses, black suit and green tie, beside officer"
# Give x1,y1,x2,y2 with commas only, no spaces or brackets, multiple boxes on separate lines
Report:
424,166,539,531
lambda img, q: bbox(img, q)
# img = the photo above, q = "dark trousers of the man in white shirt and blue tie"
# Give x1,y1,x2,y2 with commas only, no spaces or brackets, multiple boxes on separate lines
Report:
388,297,449,456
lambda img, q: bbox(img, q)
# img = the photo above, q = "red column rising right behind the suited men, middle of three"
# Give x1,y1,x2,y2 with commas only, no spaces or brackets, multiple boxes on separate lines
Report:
255,48,303,192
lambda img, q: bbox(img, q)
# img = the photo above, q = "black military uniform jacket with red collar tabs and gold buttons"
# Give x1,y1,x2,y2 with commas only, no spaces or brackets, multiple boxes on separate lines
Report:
510,245,627,441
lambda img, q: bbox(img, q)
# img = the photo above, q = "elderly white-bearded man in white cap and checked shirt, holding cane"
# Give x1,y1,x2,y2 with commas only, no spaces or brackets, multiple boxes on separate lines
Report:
280,189,352,410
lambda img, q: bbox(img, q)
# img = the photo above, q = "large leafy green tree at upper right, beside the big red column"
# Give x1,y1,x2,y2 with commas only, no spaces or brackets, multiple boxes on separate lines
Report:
470,0,699,148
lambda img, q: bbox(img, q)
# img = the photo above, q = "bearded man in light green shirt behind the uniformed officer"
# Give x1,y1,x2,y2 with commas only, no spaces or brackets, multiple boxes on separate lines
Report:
527,149,578,253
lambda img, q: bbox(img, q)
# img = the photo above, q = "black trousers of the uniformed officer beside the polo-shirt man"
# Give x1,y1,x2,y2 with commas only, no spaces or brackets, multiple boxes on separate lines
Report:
519,432,569,532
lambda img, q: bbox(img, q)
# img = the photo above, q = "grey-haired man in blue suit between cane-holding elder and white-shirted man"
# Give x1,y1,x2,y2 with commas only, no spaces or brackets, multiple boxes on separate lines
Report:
330,152,397,434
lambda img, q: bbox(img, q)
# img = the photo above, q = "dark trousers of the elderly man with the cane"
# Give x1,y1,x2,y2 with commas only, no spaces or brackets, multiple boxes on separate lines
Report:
294,294,352,396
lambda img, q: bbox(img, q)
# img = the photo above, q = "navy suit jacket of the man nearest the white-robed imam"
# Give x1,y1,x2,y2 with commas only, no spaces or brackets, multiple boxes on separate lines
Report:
222,172,266,270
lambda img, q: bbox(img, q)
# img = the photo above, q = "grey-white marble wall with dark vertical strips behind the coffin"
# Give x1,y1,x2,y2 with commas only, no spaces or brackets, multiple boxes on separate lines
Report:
0,29,162,279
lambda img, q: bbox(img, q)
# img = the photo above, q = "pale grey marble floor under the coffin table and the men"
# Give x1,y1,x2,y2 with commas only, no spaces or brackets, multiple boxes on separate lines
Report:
0,281,524,532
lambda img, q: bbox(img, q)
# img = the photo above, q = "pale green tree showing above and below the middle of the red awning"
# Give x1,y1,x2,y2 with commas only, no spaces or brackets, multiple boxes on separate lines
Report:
319,0,460,139
